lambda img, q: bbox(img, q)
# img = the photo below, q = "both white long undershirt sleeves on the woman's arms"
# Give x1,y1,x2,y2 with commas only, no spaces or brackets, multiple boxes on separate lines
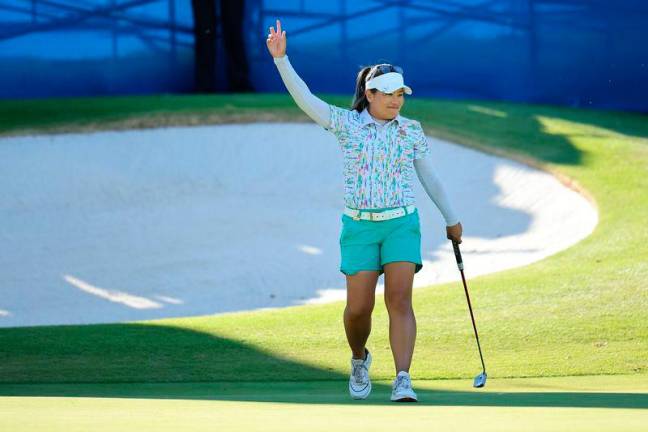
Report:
274,55,459,226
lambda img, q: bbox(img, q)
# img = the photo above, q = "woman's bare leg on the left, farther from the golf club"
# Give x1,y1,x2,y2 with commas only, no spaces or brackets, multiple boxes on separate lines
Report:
344,271,379,359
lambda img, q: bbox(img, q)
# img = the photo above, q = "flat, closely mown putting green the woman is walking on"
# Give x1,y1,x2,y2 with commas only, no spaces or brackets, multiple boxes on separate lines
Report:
0,375,648,432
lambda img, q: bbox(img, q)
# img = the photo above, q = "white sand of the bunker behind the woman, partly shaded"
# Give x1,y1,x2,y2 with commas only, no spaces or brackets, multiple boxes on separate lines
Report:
0,123,597,327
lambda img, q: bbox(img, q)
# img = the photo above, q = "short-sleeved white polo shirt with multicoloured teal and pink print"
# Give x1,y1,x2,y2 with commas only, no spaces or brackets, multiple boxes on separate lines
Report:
325,105,431,209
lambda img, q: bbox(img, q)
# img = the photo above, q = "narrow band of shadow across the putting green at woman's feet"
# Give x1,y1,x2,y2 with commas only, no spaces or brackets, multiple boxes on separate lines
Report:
0,380,648,409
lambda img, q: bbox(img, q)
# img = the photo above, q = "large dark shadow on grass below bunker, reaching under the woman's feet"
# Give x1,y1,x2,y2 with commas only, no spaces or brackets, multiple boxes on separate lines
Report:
0,323,648,408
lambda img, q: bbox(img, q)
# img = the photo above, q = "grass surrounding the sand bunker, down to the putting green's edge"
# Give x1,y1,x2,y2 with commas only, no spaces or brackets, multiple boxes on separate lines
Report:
0,95,648,391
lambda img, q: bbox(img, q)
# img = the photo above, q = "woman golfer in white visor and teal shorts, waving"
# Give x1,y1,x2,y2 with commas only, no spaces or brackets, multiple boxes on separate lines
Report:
266,16,462,402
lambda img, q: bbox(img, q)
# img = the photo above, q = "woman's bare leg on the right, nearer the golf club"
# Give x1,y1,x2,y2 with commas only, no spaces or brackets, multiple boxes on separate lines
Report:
384,261,416,373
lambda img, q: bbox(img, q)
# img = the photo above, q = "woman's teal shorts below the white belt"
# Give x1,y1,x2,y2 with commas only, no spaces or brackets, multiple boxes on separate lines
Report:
340,207,423,275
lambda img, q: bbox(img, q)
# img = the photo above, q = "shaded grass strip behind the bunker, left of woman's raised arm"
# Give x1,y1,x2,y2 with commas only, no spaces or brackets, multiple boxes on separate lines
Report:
0,94,306,135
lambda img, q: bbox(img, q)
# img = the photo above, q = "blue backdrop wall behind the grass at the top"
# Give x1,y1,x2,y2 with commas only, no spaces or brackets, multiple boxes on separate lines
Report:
0,0,648,112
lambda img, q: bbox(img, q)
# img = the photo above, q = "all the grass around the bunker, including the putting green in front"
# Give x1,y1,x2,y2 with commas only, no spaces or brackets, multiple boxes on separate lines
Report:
0,95,648,432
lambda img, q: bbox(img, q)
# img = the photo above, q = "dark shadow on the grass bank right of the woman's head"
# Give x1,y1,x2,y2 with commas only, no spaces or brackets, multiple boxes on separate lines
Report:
406,100,648,165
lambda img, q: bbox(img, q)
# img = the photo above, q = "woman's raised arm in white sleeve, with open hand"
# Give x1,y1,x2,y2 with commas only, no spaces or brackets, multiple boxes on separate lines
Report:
266,20,331,128
